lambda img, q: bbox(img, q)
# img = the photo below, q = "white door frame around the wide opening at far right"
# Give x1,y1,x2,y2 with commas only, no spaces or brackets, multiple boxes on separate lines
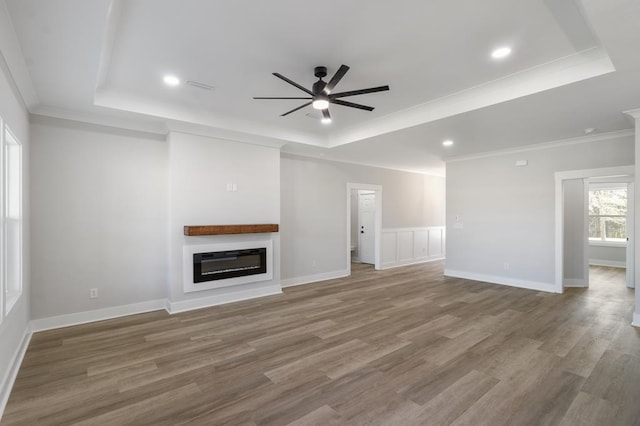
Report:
553,166,635,293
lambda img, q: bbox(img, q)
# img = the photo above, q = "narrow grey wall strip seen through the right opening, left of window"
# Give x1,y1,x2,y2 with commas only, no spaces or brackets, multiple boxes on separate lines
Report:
563,179,587,286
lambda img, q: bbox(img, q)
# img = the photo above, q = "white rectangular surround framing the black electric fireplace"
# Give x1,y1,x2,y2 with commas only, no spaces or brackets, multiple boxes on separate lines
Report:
182,240,273,293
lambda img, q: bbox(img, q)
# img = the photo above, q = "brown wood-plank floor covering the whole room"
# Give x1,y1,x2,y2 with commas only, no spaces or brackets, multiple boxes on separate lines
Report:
0,262,640,426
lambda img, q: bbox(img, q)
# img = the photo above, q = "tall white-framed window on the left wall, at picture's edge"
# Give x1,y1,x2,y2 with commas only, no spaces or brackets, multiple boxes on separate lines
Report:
0,126,23,315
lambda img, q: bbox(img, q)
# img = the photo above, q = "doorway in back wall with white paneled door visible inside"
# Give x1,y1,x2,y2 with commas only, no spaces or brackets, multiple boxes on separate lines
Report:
345,183,382,275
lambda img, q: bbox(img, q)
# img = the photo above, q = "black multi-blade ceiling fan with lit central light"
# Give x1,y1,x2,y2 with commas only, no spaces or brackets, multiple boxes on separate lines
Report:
253,65,389,123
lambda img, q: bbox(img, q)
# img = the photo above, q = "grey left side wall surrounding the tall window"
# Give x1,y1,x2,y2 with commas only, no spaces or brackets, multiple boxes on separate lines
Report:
0,43,30,415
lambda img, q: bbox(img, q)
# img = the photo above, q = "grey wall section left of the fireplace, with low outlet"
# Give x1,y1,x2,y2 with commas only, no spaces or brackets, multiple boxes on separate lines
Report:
31,117,168,319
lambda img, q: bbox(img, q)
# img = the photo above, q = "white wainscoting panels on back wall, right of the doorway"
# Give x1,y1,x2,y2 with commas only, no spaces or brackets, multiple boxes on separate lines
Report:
381,226,445,269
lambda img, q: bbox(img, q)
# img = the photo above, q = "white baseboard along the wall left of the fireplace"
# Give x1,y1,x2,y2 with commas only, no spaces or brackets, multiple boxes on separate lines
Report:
31,299,166,332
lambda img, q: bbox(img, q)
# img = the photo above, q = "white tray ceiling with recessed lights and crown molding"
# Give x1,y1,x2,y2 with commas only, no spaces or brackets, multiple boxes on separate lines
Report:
0,0,640,174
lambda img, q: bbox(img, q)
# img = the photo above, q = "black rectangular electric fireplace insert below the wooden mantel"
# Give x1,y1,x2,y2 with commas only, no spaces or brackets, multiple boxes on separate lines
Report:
193,247,267,283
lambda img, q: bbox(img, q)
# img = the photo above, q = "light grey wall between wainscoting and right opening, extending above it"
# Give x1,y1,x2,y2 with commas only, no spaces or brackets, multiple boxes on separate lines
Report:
446,137,634,290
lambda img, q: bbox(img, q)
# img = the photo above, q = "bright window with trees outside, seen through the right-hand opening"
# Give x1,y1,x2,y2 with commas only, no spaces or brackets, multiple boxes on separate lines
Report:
589,185,627,243
